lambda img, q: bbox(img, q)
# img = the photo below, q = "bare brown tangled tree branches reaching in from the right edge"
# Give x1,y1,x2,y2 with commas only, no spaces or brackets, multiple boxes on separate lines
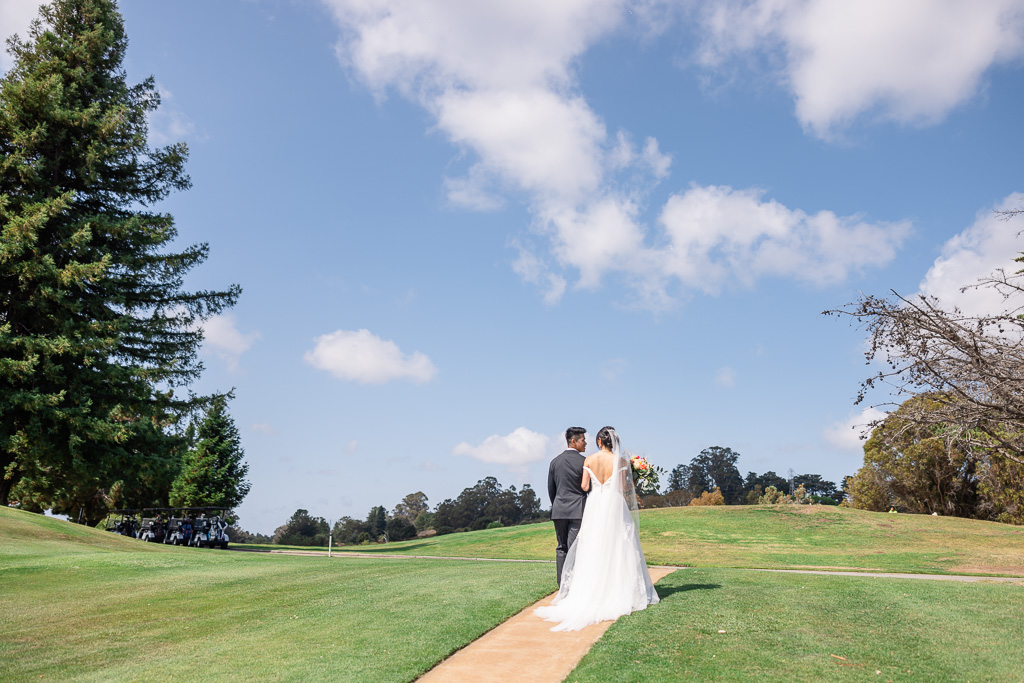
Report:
824,209,1024,464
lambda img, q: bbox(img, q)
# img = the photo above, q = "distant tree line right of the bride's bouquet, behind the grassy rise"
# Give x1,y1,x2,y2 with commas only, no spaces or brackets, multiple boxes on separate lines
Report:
642,445,843,508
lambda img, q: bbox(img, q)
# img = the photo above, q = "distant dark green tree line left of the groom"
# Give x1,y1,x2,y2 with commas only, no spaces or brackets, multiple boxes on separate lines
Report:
264,477,549,546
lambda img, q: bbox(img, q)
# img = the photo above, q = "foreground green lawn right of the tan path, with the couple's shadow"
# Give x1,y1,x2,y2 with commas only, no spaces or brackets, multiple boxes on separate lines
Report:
566,569,1024,683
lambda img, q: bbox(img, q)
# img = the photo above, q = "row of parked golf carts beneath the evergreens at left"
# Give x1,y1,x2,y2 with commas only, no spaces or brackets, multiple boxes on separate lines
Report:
106,508,228,550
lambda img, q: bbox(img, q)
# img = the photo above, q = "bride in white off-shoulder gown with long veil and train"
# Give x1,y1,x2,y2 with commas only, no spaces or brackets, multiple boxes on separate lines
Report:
535,427,658,631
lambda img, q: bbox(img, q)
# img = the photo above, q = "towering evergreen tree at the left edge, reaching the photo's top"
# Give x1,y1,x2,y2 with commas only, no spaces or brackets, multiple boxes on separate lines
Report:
0,0,239,517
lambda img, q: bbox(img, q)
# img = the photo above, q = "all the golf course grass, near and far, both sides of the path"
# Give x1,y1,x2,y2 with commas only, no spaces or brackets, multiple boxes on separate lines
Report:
0,506,1024,681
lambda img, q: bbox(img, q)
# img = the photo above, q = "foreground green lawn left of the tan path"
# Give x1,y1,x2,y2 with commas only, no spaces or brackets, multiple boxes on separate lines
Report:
0,508,555,681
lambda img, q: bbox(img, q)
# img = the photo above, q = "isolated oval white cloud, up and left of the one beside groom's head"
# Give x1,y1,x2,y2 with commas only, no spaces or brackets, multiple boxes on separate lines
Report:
302,330,437,384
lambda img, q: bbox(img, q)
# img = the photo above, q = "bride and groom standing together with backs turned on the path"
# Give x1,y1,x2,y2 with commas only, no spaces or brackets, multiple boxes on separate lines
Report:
535,427,658,631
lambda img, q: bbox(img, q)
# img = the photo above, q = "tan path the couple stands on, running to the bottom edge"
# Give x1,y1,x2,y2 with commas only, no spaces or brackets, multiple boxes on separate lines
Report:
418,567,678,683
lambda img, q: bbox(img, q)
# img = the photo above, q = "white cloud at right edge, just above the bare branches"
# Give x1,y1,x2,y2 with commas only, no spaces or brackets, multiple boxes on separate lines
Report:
921,194,1024,315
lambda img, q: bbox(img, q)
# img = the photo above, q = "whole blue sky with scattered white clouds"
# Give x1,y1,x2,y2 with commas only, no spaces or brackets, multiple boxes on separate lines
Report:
0,0,1024,533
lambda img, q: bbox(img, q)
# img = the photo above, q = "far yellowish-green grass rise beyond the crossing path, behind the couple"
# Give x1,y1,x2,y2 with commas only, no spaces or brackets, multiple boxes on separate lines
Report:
245,505,1024,577
